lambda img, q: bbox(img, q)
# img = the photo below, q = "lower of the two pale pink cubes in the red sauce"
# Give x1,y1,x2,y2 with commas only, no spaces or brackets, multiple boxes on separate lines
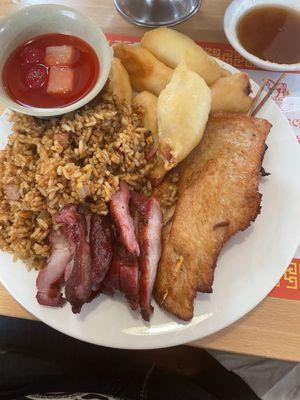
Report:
47,67,74,94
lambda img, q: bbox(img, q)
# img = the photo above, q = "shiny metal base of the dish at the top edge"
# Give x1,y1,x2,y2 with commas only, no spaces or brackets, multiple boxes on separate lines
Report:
114,0,202,27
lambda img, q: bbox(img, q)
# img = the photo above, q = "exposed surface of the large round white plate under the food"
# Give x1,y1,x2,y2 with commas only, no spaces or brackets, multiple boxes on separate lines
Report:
0,63,300,349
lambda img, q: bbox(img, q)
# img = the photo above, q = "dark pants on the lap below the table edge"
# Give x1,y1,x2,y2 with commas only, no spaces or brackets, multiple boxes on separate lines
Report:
0,317,258,400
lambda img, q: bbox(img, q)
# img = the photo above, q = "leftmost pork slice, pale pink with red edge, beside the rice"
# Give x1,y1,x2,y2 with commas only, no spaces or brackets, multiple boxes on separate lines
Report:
36,231,72,307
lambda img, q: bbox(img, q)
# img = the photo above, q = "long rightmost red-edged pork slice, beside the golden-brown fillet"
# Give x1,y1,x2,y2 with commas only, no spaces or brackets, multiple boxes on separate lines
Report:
131,192,163,321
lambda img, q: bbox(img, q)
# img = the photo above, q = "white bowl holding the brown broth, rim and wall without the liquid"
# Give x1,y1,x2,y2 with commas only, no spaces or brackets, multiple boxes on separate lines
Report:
224,0,300,71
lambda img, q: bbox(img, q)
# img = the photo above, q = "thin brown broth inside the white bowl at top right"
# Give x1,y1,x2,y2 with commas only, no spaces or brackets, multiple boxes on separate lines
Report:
237,6,300,64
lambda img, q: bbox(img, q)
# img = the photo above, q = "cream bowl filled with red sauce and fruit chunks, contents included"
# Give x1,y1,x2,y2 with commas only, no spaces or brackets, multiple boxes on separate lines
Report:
0,4,112,117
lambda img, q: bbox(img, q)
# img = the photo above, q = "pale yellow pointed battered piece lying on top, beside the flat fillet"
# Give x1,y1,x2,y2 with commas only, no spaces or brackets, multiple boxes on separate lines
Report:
157,62,211,170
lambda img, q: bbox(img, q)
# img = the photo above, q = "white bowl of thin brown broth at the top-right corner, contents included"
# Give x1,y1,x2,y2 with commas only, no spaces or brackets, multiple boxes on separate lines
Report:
224,0,300,71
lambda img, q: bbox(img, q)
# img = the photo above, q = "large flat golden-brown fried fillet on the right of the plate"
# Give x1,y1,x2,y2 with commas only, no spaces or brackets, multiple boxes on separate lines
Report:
155,113,271,321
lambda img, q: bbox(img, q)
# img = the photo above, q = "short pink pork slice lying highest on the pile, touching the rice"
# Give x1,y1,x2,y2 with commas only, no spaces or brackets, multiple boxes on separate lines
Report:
110,182,140,256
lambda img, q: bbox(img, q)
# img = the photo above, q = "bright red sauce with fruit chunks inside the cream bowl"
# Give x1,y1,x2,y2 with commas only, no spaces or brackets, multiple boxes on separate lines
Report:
2,33,100,108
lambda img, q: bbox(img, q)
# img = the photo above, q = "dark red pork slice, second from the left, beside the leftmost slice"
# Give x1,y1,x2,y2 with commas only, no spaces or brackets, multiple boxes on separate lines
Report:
55,204,92,313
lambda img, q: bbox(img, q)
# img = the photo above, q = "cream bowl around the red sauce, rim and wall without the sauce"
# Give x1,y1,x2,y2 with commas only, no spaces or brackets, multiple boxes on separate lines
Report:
0,4,113,117
